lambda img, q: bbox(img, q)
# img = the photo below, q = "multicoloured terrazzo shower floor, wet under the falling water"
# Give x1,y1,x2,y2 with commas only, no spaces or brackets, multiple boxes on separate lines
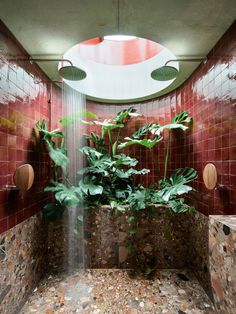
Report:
20,269,215,314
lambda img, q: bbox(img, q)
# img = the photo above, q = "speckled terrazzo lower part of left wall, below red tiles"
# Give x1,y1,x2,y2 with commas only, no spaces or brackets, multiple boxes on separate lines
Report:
0,214,47,314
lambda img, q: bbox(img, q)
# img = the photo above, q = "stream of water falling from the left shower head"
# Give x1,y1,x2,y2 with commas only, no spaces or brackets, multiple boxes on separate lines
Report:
62,84,86,271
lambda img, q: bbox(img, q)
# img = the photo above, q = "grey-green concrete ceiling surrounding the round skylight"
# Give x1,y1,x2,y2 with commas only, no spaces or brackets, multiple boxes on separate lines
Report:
0,0,236,102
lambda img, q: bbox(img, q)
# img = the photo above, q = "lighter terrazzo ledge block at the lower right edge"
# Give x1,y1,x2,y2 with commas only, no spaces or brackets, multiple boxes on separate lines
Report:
209,216,236,314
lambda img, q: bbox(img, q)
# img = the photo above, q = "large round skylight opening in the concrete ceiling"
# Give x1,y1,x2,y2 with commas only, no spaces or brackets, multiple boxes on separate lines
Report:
59,35,178,101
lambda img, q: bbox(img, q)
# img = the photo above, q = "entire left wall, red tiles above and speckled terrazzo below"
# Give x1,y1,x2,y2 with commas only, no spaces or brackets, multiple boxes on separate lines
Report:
0,22,61,314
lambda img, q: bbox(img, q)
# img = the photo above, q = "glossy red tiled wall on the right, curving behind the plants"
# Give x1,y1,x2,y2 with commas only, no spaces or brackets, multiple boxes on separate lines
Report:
87,23,236,215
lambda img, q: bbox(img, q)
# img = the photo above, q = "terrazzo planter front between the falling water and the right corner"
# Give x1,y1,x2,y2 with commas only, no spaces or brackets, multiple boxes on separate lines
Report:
85,206,190,269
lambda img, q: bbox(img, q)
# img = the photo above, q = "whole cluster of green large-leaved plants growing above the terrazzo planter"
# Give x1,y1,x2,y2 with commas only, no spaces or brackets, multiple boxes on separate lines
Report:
36,107,197,228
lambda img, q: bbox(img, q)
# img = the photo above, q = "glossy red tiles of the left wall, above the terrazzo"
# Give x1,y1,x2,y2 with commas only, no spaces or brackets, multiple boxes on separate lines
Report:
0,22,62,233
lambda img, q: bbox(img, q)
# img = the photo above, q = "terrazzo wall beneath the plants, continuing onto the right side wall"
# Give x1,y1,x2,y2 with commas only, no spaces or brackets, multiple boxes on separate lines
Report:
49,206,213,299
